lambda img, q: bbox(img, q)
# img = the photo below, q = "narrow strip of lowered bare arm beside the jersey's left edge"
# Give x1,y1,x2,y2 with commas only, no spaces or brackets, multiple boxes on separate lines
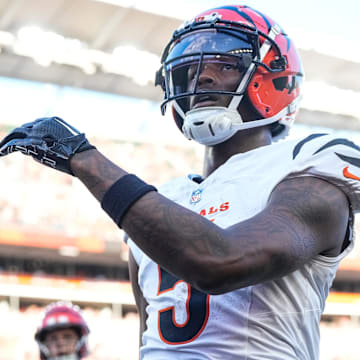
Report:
129,251,147,346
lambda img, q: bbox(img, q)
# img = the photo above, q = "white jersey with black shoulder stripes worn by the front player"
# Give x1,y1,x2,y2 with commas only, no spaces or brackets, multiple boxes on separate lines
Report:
129,134,360,360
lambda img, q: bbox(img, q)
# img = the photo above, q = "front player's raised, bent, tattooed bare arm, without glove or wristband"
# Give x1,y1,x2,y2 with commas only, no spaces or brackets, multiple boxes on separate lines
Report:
72,150,349,294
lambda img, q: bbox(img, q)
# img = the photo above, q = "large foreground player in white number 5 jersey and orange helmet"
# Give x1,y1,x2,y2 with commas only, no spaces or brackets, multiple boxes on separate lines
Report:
0,5,360,360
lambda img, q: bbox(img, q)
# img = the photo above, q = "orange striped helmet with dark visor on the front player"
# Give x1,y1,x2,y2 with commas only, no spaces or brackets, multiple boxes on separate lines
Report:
156,5,303,145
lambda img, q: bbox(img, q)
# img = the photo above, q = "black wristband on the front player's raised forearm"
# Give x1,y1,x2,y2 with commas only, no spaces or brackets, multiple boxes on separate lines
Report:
101,174,157,227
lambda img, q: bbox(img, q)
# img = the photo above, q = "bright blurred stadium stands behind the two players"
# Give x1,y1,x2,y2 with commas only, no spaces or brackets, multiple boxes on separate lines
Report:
0,0,360,360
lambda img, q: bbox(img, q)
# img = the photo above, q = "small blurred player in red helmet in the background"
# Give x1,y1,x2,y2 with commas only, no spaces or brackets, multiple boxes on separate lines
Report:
35,301,89,360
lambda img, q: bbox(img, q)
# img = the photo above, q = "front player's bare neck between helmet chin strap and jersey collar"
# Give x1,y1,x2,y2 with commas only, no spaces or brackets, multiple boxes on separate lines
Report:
203,127,271,178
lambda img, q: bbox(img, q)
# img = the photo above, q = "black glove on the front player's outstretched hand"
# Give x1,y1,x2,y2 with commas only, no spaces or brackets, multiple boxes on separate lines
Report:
0,117,95,175
